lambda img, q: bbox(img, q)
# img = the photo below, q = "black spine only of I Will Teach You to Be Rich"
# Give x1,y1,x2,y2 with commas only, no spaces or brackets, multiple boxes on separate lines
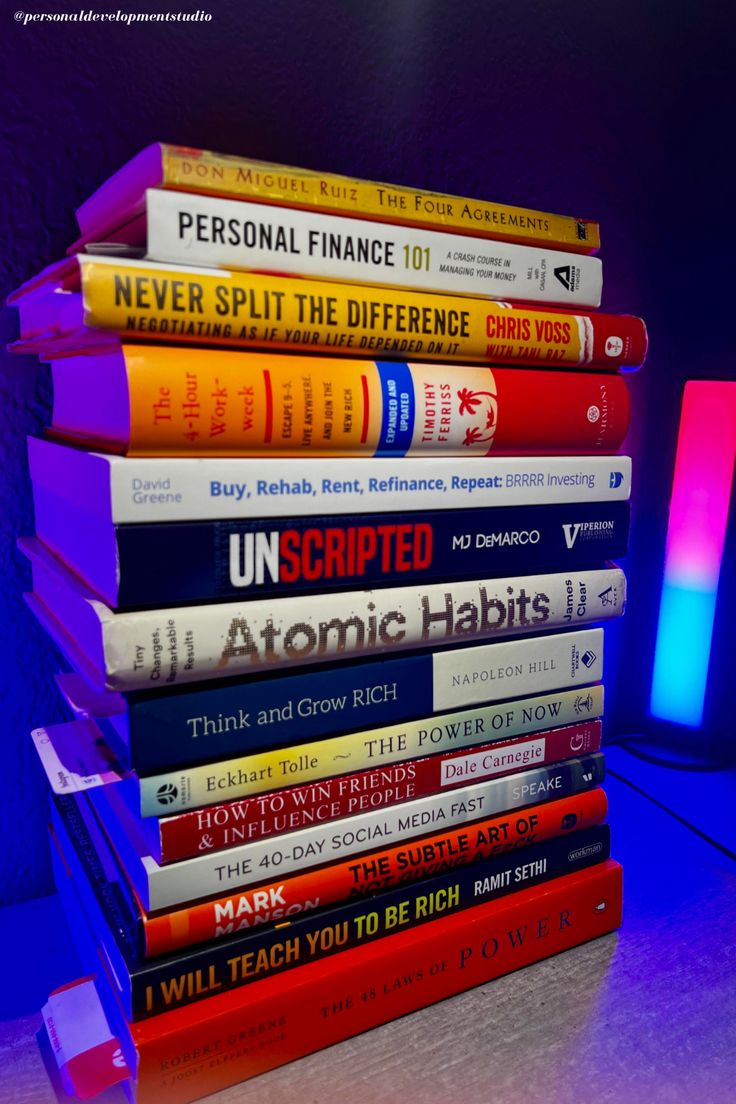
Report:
130,825,610,1020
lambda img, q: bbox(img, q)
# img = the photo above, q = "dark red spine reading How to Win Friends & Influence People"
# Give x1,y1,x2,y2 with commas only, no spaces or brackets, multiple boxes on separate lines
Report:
159,720,601,863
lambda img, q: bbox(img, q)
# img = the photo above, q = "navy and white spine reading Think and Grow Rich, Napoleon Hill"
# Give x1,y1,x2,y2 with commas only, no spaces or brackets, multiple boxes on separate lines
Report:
125,629,601,775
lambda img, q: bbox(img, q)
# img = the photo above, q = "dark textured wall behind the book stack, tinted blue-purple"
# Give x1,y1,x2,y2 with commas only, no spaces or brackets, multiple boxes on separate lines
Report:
0,0,734,902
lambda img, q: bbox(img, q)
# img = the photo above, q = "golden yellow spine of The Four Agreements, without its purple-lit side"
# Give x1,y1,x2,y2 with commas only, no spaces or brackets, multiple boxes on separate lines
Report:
162,146,600,253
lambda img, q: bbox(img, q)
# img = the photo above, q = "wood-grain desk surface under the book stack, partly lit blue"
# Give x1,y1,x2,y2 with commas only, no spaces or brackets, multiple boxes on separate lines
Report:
0,749,736,1104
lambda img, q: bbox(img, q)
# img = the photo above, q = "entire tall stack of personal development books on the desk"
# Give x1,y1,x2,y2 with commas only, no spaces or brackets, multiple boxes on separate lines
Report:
11,146,646,1104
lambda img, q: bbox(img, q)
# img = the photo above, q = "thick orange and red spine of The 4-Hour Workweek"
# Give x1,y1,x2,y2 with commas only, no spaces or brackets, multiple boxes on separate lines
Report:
93,346,630,459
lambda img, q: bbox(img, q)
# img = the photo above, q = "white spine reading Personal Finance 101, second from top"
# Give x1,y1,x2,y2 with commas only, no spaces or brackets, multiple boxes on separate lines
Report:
146,189,602,307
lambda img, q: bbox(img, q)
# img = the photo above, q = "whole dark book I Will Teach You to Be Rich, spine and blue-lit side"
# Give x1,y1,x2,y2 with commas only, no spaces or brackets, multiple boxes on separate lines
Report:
53,786,610,1020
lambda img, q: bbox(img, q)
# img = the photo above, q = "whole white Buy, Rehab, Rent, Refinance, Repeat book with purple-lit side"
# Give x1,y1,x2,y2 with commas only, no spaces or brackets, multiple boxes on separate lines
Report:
29,437,631,521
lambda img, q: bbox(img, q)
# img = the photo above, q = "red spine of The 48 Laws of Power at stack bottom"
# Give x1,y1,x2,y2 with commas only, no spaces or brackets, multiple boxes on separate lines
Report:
130,860,622,1104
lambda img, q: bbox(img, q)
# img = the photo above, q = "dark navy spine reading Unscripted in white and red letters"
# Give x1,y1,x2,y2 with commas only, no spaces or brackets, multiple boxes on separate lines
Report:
116,502,629,609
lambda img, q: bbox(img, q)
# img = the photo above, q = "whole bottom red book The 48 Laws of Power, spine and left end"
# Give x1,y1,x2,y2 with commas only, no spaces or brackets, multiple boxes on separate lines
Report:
44,860,622,1104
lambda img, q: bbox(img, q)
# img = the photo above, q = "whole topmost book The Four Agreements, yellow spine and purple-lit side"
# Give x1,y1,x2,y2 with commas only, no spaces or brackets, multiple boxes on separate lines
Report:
71,142,600,253
